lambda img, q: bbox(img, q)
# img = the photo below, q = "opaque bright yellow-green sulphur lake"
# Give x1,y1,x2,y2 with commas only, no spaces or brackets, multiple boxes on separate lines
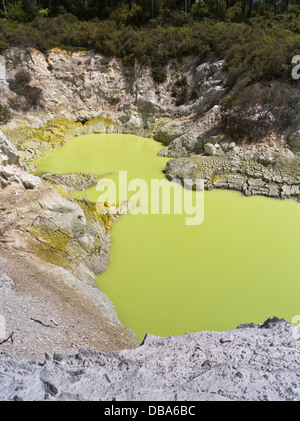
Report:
37,135,300,339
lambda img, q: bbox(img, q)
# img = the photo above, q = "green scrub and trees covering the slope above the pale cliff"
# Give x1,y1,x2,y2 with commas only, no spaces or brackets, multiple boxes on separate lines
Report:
0,0,300,138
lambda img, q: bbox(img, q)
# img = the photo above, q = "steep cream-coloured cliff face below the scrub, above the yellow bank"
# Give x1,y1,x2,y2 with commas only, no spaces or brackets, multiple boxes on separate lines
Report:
0,48,225,125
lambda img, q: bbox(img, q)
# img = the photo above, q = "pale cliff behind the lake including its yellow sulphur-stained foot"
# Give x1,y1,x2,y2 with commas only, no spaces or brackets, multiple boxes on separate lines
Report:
0,48,300,191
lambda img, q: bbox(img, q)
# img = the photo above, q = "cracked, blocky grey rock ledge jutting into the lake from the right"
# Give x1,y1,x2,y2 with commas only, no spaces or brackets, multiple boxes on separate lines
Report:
165,153,300,201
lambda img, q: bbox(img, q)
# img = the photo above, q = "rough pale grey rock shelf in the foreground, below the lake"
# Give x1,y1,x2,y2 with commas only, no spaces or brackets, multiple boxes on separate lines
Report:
0,317,300,401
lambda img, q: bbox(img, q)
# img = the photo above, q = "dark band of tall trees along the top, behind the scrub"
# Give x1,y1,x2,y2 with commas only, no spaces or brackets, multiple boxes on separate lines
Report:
1,0,299,26
